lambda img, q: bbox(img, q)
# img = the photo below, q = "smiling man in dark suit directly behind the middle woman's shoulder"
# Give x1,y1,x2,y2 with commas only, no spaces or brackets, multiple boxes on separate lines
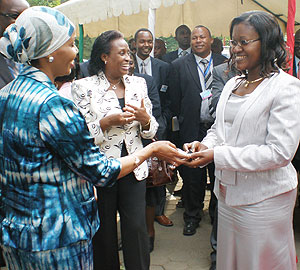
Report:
134,28,173,226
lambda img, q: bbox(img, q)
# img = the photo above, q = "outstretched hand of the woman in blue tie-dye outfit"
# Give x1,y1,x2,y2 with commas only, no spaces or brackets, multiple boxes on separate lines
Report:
150,141,190,167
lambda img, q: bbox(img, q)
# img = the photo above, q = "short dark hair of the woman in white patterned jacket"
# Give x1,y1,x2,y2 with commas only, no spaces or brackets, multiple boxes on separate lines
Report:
88,30,124,76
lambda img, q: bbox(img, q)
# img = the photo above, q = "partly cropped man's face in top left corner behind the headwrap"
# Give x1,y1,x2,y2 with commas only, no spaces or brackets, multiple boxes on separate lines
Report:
0,0,29,37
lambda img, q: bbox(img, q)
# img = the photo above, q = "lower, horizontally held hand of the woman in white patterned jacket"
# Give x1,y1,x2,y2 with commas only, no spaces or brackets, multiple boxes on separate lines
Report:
100,112,135,131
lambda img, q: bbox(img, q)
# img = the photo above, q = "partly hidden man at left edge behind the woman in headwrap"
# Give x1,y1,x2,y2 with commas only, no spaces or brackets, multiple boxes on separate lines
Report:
0,0,29,89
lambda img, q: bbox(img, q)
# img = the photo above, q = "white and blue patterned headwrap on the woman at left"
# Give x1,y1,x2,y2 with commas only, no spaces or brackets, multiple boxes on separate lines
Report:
0,6,75,64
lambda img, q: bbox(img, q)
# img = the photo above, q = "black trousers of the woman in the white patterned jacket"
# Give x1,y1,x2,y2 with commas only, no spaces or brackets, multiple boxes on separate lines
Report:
93,173,150,270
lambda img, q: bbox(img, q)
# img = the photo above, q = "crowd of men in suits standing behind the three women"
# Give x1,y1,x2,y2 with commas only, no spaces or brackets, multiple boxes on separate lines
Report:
0,0,300,269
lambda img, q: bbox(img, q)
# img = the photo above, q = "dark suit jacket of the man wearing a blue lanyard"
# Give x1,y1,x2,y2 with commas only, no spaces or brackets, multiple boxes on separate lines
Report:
169,53,226,143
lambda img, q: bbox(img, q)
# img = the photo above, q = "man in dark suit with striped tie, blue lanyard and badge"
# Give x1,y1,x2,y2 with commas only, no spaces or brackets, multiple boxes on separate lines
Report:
169,25,226,235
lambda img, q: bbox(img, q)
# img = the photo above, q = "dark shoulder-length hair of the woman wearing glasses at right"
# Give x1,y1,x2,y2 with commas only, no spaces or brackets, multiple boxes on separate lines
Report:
230,11,287,76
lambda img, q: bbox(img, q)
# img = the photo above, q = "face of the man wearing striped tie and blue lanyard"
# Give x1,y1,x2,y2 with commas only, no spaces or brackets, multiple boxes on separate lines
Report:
191,27,213,58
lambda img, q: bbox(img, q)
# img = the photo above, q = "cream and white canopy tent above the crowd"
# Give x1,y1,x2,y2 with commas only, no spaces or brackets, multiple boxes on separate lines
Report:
56,0,300,60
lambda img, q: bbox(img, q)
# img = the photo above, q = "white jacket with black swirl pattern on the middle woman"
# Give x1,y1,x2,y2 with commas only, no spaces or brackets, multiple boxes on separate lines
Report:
72,72,158,180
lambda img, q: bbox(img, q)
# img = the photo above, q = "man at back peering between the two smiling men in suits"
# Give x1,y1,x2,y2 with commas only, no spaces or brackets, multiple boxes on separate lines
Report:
162,24,191,63
